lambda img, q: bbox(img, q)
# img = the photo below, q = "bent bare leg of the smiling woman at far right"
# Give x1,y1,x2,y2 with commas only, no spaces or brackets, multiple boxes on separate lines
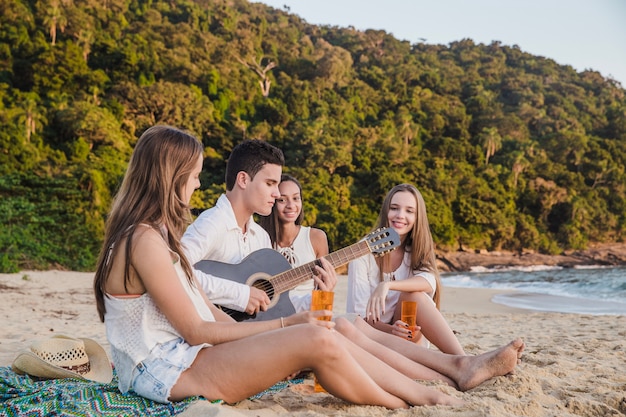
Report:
393,291,465,355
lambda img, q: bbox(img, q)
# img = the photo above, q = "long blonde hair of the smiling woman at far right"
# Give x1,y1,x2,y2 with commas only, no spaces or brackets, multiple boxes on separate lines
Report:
376,184,441,308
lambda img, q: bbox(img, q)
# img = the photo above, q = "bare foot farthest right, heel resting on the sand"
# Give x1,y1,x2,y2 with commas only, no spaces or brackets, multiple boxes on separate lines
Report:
457,339,525,391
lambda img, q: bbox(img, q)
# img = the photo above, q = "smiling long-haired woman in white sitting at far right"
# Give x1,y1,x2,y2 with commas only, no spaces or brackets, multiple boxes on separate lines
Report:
347,184,465,355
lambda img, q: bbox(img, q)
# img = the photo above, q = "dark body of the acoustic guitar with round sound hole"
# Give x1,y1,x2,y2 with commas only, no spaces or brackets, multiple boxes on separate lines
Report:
195,249,296,321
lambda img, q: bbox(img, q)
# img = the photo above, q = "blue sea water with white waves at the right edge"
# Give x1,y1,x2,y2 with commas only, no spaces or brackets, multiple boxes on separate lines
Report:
441,266,626,315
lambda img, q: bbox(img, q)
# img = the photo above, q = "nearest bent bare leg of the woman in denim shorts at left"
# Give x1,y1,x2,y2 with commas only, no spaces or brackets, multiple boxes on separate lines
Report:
170,325,408,408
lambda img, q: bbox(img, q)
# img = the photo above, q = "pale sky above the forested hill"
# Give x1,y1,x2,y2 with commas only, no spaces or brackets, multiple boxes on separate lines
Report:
252,0,626,88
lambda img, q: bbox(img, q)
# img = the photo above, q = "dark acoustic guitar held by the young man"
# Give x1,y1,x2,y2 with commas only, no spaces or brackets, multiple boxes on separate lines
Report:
194,227,400,321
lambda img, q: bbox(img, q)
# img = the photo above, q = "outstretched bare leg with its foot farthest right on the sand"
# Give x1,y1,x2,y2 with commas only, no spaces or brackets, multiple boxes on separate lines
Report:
336,317,524,391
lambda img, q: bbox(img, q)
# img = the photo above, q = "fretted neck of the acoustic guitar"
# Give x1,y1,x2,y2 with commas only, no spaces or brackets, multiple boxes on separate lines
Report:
270,241,371,294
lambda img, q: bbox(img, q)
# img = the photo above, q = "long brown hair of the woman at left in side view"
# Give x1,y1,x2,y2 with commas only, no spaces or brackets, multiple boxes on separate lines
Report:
94,125,203,321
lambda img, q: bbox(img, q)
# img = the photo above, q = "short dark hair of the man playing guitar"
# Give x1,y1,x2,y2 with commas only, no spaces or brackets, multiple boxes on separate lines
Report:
226,139,285,191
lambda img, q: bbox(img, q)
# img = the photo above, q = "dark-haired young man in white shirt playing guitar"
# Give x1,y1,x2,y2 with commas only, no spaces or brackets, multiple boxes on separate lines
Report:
182,140,337,314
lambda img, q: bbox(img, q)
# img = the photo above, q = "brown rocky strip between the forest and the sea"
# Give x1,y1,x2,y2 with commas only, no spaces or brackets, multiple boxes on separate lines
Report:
437,243,626,272
